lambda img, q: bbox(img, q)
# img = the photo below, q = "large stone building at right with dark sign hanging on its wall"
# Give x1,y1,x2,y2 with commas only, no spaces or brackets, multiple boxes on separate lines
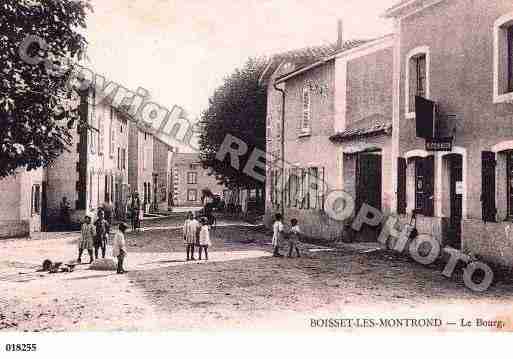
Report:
385,0,513,266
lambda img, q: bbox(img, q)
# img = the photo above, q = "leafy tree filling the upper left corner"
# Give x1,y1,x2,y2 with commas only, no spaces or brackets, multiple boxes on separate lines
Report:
0,0,92,178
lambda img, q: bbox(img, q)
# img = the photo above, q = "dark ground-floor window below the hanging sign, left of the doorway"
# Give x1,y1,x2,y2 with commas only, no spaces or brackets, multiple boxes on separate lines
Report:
415,156,435,217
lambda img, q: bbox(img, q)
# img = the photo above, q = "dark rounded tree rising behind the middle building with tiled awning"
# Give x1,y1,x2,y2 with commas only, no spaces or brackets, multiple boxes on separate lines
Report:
199,58,267,188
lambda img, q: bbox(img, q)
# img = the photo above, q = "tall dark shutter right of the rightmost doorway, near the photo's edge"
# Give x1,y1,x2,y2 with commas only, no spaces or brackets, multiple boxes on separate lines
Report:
481,151,497,222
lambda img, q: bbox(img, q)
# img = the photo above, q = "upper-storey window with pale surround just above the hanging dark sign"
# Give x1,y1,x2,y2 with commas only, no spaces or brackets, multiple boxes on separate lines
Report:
405,46,429,118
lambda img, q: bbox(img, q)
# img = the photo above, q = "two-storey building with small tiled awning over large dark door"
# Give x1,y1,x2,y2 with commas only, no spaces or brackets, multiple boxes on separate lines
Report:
266,28,394,239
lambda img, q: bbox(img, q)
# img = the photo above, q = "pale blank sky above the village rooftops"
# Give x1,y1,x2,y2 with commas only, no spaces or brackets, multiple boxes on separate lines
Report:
83,0,398,115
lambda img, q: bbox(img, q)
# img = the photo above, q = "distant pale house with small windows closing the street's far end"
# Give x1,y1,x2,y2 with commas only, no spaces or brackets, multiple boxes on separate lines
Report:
171,153,225,207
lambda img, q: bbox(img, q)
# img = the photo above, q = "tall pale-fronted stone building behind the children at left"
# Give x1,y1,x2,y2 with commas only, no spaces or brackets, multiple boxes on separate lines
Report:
45,90,129,224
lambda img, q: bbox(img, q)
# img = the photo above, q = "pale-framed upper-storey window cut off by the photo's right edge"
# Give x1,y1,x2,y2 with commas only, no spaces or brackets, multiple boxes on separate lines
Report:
493,13,513,103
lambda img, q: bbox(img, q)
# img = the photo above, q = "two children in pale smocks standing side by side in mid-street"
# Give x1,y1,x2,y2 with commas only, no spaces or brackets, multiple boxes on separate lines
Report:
183,212,212,261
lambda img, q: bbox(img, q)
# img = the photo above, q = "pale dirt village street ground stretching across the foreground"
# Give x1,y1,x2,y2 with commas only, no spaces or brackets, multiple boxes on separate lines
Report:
0,222,513,331
